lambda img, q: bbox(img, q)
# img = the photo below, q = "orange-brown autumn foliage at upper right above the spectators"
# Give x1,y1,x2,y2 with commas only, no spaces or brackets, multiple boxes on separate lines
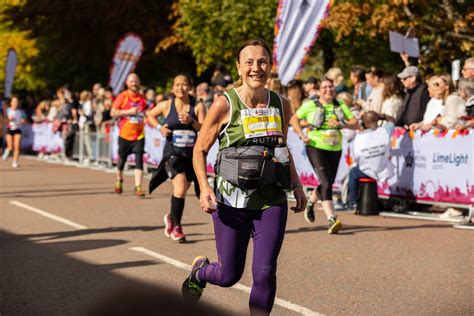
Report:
319,0,474,72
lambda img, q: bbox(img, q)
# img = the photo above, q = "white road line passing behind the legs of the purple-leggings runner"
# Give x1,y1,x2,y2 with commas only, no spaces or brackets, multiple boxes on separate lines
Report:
130,247,323,315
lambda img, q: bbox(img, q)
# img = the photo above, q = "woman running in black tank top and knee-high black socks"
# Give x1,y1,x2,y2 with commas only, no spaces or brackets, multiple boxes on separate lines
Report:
148,75,206,242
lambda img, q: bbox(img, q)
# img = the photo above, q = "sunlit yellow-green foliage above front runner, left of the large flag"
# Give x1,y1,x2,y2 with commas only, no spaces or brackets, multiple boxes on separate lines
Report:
157,0,278,78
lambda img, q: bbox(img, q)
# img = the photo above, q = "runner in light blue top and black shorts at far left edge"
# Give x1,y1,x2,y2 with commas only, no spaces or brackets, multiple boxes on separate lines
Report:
2,96,26,168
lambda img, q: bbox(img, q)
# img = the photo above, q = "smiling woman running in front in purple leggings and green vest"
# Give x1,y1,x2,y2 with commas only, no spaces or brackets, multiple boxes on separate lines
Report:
182,40,306,314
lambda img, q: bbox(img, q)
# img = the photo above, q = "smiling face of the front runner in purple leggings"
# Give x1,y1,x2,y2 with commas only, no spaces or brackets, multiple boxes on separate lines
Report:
236,45,271,89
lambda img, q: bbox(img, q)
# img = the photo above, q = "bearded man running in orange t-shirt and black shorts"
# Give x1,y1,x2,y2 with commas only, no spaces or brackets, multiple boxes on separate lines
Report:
111,73,146,197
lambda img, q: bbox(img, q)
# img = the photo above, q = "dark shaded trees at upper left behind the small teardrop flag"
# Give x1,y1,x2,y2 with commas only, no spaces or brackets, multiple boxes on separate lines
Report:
0,0,191,90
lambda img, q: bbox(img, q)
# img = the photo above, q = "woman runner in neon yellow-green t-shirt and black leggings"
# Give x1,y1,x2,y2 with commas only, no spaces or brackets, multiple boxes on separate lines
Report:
291,77,359,234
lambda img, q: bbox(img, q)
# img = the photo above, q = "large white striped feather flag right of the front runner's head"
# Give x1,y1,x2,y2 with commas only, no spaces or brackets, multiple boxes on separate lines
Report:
273,0,331,85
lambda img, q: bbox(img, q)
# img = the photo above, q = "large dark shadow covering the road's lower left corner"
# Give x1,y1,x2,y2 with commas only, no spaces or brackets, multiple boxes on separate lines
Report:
0,230,228,316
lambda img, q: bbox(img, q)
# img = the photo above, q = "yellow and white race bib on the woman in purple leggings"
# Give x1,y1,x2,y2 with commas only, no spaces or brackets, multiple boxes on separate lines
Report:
240,108,283,139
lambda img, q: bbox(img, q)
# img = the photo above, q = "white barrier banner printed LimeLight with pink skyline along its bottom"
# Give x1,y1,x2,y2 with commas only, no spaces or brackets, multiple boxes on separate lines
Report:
384,128,474,204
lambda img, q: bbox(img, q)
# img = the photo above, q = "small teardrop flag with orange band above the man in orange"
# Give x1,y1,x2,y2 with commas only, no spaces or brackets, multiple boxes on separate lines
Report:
109,33,143,95
